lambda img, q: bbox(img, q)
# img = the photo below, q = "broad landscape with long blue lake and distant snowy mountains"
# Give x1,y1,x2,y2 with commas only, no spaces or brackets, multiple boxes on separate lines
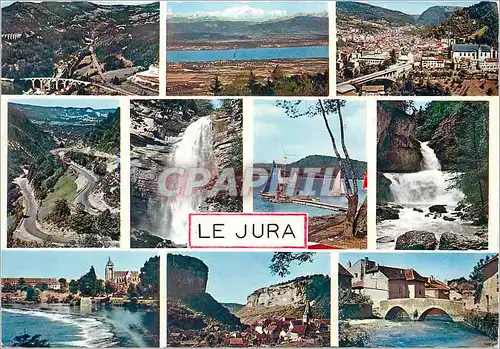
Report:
167,2,329,96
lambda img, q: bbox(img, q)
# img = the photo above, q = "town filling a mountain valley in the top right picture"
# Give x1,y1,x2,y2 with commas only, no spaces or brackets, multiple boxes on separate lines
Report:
336,2,498,96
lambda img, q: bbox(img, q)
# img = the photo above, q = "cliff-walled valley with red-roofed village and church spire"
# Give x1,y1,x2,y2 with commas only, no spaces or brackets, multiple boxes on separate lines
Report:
167,253,330,347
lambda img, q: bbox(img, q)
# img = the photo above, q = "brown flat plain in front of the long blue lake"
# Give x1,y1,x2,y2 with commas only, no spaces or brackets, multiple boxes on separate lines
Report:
167,58,329,95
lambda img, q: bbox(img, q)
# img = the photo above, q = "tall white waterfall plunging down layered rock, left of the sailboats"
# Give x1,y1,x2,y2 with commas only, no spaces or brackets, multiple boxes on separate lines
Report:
159,117,213,244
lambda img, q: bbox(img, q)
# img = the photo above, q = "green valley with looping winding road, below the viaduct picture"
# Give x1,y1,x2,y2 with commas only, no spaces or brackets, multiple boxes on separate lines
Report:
7,100,120,247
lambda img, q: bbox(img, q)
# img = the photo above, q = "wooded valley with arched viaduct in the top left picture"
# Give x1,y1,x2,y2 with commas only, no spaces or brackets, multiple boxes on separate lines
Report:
2,1,160,95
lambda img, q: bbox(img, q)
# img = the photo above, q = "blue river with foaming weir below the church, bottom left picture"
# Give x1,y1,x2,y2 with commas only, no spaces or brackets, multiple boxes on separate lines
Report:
2,305,159,348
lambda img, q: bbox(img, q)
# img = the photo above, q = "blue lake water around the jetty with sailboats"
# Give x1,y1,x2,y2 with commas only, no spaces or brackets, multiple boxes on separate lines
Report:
253,176,366,217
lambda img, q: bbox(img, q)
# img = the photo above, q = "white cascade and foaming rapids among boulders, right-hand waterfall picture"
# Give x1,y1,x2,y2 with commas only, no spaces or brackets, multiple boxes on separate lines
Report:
377,142,477,249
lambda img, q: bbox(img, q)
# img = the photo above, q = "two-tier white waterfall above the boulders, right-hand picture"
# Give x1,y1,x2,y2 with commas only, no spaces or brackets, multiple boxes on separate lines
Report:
384,142,464,206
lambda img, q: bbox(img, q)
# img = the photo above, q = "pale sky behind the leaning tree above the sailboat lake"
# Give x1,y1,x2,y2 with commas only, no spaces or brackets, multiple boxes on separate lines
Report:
253,100,366,163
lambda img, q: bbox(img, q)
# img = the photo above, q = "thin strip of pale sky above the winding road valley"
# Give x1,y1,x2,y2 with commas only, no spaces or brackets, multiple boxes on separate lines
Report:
9,98,120,109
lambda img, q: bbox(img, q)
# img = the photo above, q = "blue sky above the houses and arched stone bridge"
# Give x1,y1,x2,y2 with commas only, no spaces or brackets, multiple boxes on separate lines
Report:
340,253,492,281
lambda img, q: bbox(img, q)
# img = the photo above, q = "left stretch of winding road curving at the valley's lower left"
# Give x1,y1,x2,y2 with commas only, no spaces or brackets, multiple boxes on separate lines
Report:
14,178,73,245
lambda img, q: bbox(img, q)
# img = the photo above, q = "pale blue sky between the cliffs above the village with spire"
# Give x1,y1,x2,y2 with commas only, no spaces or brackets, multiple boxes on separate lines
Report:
172,252,330,304
